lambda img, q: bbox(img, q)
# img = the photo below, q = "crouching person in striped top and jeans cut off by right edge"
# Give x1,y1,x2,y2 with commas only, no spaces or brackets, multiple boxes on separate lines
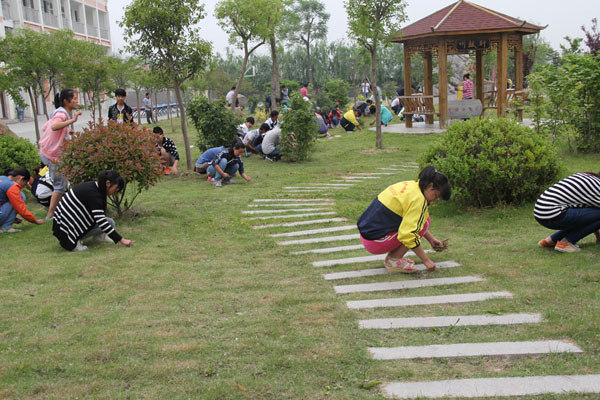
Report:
533,172,600,253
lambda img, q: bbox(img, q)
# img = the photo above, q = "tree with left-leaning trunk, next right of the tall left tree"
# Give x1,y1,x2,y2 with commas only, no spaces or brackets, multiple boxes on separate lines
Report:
215,0,283,107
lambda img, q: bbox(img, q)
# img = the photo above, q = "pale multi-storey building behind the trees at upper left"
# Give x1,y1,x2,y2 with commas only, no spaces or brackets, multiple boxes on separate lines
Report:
0,0,111,119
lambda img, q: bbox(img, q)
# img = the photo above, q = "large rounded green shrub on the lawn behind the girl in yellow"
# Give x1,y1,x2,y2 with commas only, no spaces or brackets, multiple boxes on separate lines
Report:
420,118,560,207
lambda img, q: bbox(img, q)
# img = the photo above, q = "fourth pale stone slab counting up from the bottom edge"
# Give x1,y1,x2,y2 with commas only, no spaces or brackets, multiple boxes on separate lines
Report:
346,292,512,310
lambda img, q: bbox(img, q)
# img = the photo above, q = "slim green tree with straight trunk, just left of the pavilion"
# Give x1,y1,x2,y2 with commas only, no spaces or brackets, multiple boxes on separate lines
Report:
344,0,406,149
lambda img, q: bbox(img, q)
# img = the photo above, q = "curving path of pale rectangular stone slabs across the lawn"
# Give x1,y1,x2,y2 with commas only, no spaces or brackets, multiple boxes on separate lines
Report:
243,170,600,399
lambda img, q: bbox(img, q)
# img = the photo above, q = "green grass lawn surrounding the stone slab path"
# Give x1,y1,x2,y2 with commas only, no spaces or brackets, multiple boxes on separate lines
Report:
0,114,600,399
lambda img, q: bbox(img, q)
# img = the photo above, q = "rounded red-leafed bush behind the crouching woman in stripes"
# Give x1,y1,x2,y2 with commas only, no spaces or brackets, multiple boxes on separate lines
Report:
59,121,161,216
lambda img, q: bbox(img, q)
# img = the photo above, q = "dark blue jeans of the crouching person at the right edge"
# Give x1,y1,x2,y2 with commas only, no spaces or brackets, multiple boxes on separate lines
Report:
538,207,600,244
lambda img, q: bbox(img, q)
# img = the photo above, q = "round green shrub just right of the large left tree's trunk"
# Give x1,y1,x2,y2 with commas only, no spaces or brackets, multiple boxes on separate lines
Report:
187,96,242,151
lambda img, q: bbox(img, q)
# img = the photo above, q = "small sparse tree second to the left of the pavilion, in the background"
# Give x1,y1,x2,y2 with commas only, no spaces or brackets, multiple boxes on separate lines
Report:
285,0,329,87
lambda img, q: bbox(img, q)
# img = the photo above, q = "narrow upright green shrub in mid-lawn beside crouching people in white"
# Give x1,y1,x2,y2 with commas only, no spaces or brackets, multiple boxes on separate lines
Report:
281,93,319,162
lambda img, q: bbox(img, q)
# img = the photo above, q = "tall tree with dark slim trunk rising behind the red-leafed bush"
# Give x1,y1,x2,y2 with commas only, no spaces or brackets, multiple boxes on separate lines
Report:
120,0,212,170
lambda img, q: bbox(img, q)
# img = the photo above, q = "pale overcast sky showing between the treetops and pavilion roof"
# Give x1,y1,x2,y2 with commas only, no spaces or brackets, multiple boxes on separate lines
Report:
108,0,600,54
